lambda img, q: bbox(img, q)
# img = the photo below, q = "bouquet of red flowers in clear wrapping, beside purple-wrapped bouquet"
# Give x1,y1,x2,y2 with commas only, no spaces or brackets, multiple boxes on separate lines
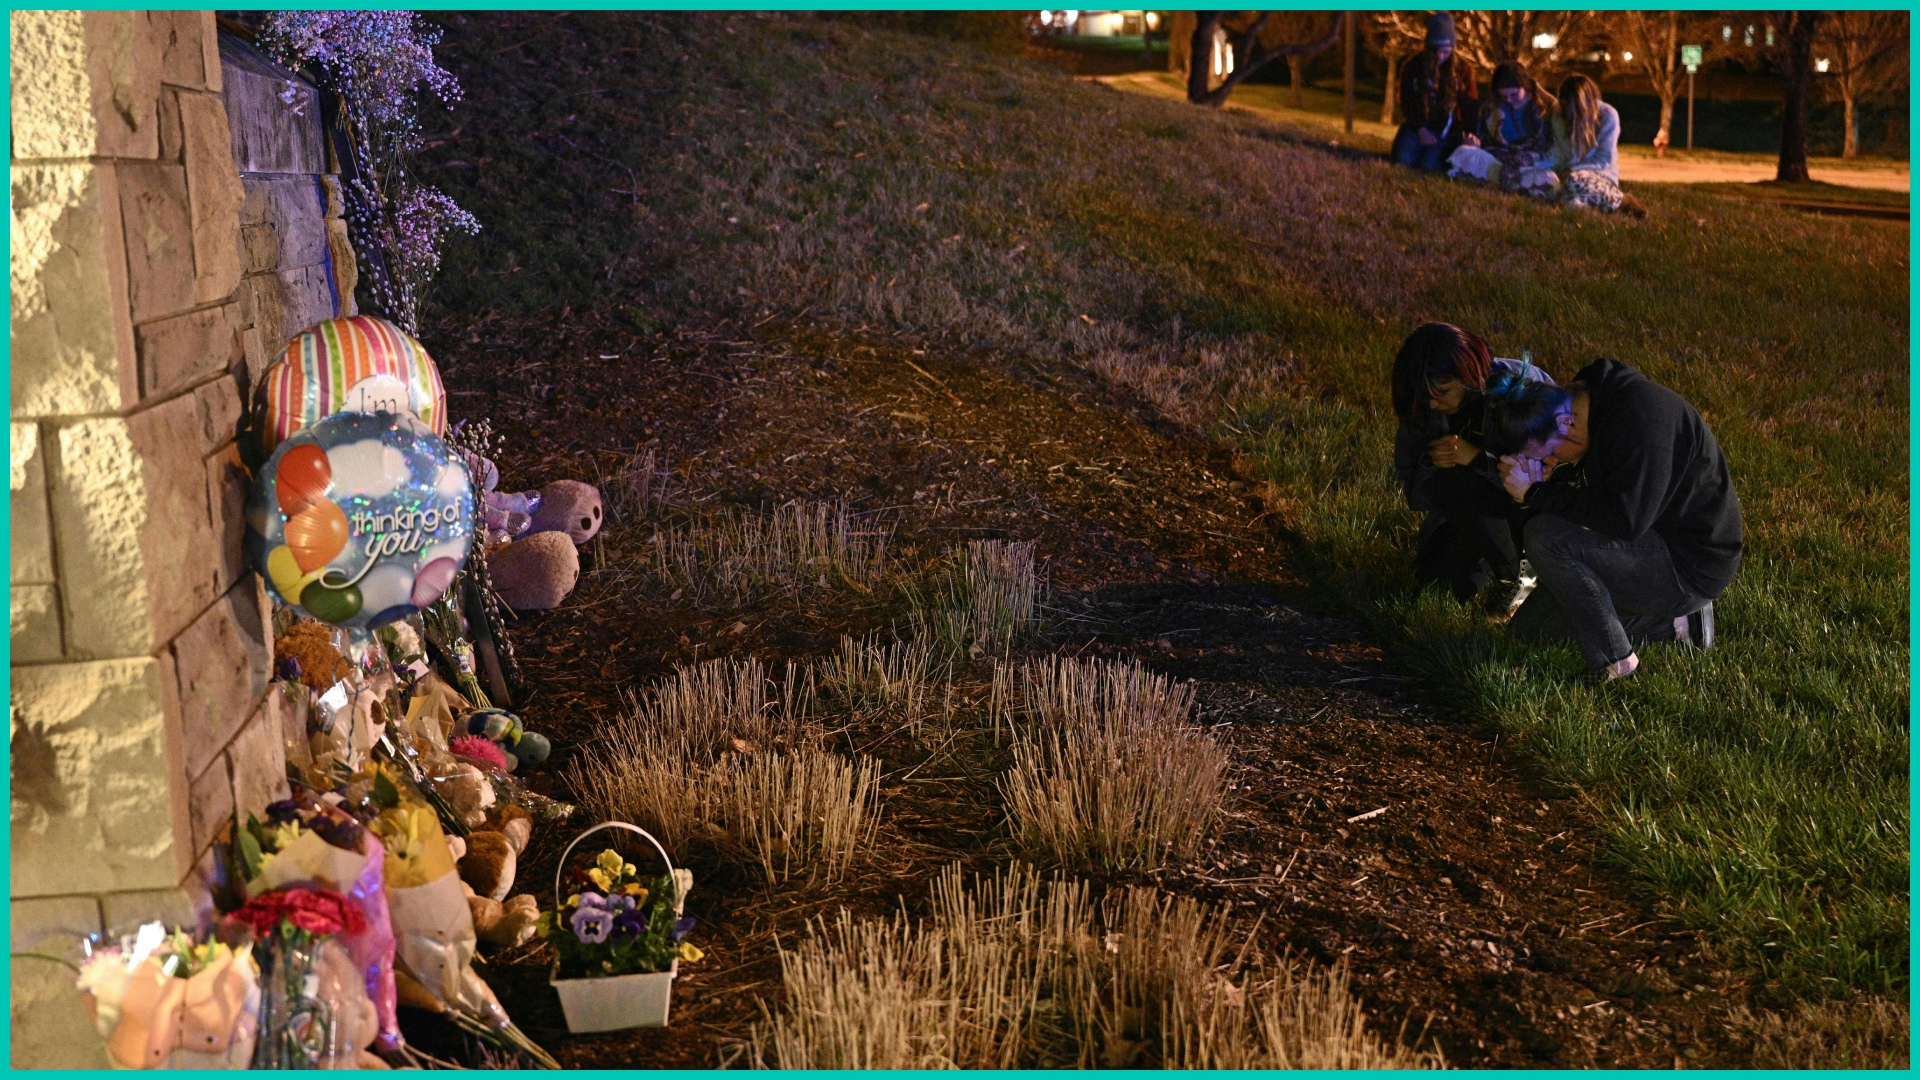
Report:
227,888,386,1068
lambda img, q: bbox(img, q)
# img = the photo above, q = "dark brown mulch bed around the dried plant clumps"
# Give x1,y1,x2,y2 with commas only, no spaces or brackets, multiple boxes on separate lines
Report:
424,311,1745,1067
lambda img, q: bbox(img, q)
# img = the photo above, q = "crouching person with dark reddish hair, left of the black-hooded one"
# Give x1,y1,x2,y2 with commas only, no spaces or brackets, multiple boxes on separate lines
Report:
1392,323,1549,603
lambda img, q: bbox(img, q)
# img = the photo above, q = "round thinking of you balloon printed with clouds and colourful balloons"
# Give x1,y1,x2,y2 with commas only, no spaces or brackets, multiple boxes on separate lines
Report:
246,413,474,630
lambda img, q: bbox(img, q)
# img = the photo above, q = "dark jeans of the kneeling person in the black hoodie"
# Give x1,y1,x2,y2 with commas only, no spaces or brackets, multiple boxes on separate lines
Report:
1509,513,1713,669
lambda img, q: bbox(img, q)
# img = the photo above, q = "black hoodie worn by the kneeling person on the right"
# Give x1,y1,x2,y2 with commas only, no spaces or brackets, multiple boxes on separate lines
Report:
1526,359,1741,598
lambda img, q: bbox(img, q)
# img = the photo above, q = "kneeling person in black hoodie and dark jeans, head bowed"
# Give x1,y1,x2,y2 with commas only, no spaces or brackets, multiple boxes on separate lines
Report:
1500,359,1741,682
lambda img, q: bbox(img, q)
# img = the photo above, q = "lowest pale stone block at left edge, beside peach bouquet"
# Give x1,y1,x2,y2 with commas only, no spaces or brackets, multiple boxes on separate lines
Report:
8,896,108,1068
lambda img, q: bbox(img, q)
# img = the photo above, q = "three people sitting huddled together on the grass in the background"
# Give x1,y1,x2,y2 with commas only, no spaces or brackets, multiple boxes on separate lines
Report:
1394,12,1645,215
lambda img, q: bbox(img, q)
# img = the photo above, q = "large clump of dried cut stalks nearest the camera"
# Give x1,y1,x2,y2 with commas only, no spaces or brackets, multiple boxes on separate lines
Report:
753,867,1440,1068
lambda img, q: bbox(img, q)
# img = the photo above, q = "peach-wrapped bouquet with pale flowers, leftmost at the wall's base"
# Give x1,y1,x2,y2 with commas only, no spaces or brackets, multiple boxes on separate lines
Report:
77,922,261,1068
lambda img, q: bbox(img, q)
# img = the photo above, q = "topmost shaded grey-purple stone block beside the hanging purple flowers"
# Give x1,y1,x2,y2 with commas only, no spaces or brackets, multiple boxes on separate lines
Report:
221,35,326,175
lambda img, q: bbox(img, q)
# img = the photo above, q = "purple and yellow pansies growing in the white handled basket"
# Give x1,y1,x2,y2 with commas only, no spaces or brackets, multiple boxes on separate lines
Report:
540,847,703,978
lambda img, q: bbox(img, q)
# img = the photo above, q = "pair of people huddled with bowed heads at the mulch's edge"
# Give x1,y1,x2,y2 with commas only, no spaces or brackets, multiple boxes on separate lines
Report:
1394,323,1741,682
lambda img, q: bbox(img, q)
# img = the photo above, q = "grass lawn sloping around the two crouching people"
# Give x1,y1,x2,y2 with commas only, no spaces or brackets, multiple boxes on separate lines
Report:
426,13,1908,997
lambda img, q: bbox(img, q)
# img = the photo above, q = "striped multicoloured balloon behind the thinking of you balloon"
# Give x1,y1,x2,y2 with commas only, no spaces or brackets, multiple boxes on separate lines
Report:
261,315,447,454
